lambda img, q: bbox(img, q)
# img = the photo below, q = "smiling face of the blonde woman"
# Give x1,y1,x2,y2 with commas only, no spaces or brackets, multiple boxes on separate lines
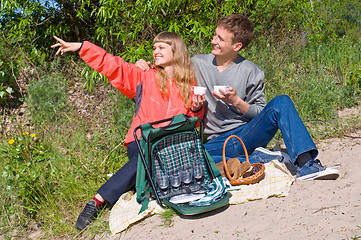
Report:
153,42,173,68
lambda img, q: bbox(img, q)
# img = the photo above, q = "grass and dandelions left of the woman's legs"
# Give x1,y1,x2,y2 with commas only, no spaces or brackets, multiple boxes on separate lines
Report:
0,110,131,238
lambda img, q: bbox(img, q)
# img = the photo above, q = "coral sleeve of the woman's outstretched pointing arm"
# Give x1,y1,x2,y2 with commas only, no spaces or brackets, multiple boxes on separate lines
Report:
79,41,144,99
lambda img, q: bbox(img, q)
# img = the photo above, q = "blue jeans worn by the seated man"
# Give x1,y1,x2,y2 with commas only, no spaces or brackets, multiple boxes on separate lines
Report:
204,95,318,164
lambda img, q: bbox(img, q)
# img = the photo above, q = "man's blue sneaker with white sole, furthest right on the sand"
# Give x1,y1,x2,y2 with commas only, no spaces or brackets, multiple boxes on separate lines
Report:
296,159,340,180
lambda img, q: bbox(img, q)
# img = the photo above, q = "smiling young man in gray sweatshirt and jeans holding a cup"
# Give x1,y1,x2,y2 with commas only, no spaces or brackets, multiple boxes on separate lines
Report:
136,14,339,180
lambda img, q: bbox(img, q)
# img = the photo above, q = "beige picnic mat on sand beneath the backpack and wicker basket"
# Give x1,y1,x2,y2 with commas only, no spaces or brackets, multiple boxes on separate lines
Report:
109,160,295,235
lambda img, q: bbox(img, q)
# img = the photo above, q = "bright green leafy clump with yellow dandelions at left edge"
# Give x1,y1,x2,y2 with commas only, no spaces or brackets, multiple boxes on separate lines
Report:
0,132,56,218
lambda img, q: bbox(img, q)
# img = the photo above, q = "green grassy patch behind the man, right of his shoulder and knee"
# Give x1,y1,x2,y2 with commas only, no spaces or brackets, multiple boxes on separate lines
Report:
244,33,361,125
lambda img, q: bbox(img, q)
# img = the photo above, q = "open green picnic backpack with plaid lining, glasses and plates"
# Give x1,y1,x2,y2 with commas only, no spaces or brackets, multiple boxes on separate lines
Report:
134,114,229,215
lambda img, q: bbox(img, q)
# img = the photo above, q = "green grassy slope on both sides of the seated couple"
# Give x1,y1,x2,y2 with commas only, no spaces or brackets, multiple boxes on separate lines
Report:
0,31,361,238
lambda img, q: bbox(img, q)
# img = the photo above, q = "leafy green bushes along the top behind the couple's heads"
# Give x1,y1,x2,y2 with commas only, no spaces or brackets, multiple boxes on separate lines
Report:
0,0,361,94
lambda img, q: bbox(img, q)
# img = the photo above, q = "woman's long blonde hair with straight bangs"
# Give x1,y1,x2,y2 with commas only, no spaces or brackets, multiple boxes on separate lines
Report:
153,32,195,107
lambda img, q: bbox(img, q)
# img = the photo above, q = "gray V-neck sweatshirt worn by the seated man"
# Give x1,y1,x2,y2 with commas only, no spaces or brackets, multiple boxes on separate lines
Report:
192,54,266,139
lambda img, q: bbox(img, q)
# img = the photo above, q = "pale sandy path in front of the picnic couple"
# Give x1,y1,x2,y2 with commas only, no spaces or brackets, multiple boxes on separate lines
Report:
115,130,361,240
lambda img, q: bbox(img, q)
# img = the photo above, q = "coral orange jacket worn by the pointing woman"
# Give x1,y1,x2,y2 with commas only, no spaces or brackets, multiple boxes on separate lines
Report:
79,41,204,145
